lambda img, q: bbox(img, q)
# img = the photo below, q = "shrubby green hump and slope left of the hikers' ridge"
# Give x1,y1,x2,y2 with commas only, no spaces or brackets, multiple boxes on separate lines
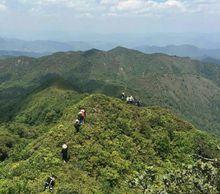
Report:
0,85,85,161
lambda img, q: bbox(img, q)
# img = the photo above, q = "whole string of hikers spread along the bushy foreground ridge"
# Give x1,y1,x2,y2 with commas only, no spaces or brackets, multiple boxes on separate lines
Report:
44,92,142,192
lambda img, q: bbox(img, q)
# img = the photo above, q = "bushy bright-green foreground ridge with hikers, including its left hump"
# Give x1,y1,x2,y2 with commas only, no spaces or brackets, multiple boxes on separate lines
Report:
0,87,220,194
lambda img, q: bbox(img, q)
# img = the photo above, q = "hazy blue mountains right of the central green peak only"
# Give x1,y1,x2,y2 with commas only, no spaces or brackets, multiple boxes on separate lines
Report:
135,45,220,60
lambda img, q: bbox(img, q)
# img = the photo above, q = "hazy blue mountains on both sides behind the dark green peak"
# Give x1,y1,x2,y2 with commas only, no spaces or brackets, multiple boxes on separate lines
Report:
0,38,220,64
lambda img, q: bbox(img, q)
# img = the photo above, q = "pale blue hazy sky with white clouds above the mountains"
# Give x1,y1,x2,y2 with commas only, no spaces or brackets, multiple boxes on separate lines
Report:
0,0,220,39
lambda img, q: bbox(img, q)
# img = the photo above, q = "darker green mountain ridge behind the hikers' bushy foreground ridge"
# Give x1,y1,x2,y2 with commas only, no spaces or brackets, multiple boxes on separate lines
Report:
0,47,220,134
